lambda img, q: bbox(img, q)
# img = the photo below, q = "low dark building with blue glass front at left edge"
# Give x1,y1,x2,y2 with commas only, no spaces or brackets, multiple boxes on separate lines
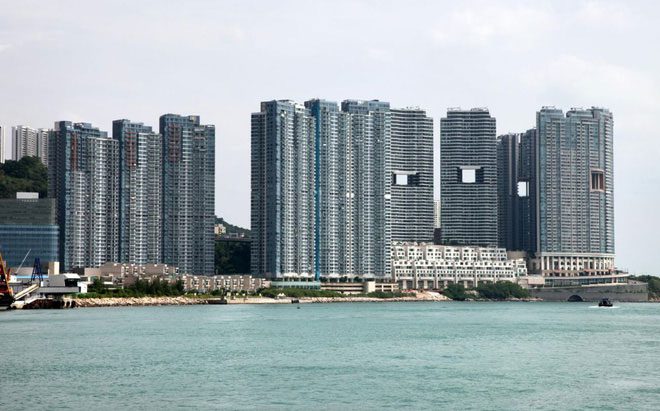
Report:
0,193,59,268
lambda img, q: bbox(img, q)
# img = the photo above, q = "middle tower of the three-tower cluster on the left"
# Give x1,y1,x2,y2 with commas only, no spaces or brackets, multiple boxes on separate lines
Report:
112,120,163,264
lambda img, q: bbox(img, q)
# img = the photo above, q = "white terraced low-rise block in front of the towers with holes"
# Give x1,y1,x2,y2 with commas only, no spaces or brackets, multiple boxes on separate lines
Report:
392,243,527,289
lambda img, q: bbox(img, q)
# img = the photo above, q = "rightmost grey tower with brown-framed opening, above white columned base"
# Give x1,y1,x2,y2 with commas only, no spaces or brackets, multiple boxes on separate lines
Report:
535,107,614,276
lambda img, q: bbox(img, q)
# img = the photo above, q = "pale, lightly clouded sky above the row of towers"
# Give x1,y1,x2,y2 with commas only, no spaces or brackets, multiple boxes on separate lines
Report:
0,0,660,274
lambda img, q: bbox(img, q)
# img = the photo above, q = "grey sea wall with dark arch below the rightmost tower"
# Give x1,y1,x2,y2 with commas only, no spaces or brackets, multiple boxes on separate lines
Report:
530,283,649,302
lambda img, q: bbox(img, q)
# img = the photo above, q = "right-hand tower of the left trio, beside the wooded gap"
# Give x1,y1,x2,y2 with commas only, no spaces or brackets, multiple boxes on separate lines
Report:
160,114,215,275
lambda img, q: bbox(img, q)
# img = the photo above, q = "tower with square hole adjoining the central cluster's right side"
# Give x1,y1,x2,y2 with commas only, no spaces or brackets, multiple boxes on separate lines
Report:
390,109,434,242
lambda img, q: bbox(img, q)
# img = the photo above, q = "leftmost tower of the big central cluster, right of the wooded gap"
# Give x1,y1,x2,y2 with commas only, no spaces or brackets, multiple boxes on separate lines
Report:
251,100,317,279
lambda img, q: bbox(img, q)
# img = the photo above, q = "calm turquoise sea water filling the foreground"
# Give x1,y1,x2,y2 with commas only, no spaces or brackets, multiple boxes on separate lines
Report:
0,303,660,410
